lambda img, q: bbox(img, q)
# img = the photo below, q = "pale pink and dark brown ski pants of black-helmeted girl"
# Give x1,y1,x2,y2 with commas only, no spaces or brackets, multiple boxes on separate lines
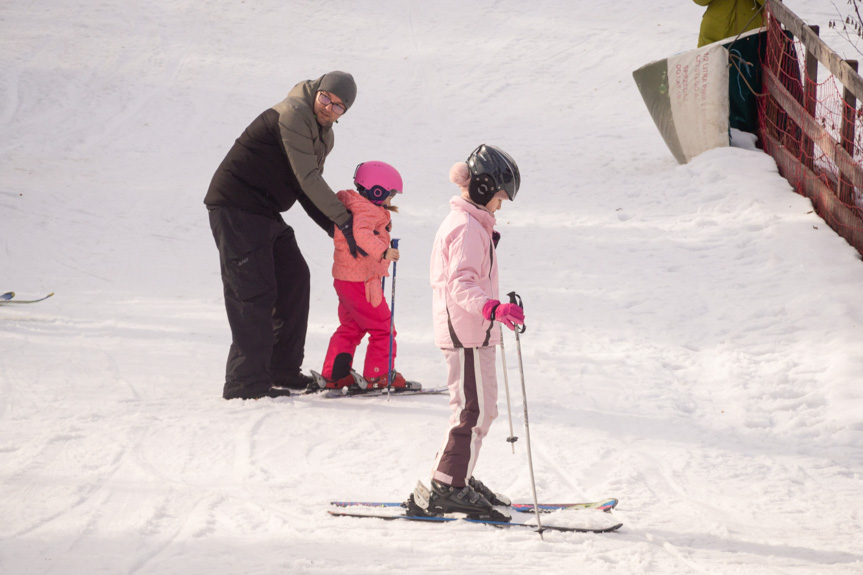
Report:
432,346,497,487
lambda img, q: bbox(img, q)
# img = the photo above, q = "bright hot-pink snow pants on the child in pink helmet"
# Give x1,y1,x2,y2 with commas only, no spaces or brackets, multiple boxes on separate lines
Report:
321,280,396,379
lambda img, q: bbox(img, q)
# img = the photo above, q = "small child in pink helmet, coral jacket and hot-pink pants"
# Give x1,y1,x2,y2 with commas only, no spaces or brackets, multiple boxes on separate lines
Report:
318,161,408,388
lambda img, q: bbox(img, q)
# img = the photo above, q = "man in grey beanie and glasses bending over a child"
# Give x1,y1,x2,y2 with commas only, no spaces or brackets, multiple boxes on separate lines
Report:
204,71,357,399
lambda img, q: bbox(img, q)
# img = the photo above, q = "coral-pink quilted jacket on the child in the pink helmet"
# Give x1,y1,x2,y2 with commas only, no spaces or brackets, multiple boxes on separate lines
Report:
333,190,390,307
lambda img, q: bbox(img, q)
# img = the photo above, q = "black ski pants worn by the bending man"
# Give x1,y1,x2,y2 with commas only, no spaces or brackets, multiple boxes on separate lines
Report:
208,206,310,399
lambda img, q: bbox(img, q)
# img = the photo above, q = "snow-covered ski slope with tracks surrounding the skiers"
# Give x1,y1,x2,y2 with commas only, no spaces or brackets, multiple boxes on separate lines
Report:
0,0,863,574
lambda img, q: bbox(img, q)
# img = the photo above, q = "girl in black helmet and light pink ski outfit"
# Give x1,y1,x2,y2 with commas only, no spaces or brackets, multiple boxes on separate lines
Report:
408,144,524,520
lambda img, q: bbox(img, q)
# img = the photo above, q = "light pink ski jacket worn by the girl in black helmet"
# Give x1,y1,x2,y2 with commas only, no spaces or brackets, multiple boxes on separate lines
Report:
429,196,500,349
